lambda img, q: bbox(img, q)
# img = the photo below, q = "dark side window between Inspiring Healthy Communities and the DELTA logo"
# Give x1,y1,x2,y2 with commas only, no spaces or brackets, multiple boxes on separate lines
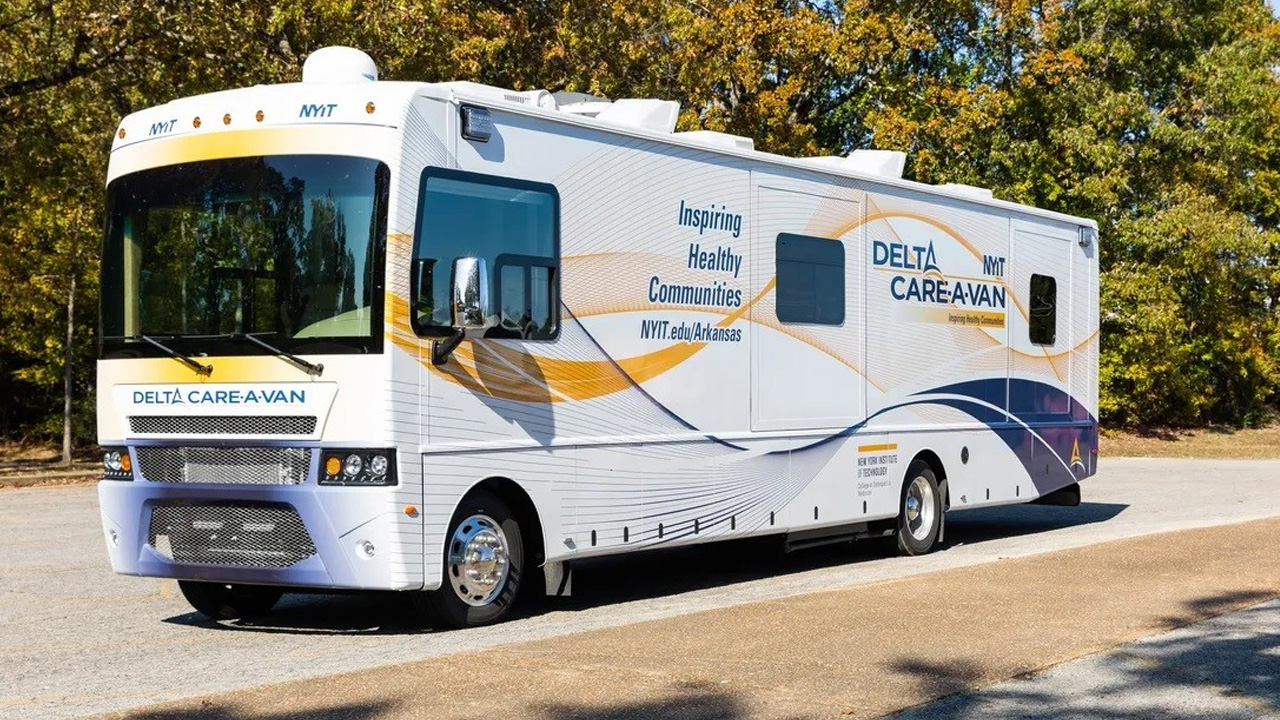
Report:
776,233,845,325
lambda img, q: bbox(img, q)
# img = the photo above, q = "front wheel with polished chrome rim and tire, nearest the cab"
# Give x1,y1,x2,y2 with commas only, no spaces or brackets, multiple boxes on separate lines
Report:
413,492,525,628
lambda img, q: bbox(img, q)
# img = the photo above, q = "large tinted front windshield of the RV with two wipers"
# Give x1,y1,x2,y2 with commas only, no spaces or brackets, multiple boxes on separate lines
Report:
101,155,389,357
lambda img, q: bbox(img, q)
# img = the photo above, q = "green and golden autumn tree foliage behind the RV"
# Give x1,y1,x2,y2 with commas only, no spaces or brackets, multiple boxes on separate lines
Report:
0,0,1280,434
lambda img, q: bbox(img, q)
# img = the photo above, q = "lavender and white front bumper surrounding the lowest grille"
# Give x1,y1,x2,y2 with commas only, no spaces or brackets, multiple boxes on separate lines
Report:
97,479,421,589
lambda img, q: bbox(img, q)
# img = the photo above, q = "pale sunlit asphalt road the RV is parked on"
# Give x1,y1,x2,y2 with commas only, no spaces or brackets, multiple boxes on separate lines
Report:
0,460,1280,719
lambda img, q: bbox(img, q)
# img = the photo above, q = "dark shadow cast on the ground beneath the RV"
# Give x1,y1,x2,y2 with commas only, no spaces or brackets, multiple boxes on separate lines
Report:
165,502,1128,634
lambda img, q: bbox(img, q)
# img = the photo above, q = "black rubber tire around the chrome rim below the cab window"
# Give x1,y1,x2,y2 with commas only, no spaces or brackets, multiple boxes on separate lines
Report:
413,492,525,628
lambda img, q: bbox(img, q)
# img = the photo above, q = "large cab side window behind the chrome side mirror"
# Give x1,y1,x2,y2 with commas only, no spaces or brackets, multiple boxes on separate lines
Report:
410,168,559,340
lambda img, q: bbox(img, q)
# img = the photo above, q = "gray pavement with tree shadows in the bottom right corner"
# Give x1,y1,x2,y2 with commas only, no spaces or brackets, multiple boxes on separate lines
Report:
890,601,1280,720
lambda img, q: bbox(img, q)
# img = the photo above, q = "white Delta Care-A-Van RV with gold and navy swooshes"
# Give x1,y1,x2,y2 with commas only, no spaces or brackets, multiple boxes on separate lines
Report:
97,49,1098,626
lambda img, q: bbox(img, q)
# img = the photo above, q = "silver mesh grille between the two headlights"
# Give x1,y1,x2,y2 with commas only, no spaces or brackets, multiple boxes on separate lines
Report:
133,446,311,486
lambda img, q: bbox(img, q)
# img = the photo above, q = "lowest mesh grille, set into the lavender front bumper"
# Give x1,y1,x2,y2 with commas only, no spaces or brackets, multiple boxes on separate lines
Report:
147,503,316,568
